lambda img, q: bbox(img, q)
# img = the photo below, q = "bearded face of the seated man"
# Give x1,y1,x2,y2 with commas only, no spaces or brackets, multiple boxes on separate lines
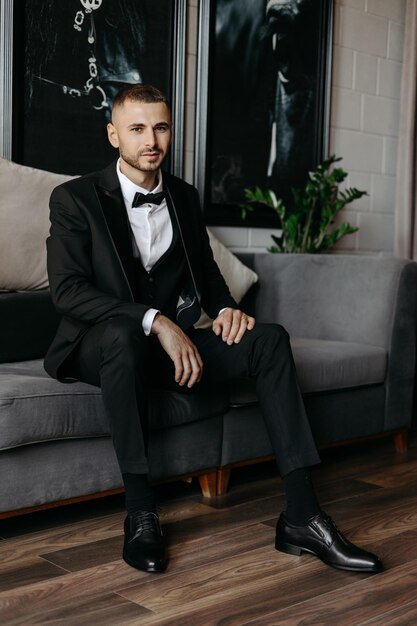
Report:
107,100,172,172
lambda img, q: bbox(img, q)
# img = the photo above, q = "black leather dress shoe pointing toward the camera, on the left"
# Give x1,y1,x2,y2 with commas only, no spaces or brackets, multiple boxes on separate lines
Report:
123,511,167,572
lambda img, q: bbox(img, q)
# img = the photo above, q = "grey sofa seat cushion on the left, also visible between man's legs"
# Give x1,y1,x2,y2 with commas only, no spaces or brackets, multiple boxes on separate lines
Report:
0,360,228,450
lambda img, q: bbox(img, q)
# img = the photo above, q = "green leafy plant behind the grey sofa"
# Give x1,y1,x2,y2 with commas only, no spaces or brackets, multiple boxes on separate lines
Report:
241,155,367,253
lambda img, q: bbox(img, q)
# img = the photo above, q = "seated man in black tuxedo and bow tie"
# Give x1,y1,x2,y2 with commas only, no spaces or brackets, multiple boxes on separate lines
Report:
45,85,382,572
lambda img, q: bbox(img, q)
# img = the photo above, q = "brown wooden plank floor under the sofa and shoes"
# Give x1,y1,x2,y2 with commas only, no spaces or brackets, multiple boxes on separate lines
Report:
0,433,417,626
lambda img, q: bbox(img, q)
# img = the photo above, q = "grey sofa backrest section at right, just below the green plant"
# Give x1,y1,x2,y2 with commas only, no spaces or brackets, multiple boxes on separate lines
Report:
254,254,414,348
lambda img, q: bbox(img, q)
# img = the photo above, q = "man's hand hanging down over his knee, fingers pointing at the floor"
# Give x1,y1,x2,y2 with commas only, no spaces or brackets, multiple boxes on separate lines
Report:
151,314,203,388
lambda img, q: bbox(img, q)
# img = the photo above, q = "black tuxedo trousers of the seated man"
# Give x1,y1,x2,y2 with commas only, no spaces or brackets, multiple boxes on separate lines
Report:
67,316,320,476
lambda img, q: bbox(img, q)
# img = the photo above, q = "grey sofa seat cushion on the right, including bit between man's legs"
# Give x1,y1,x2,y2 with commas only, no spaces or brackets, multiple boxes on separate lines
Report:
230,337,387,405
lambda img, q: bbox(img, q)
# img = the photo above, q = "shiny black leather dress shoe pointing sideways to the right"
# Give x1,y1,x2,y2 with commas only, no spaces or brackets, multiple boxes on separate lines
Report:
275,513,383,574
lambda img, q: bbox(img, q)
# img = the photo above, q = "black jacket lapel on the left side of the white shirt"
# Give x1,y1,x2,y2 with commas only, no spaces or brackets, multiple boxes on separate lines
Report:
96,163,135,293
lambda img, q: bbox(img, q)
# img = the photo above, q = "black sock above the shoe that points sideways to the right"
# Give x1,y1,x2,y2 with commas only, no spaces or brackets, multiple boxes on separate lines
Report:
282,467,321,526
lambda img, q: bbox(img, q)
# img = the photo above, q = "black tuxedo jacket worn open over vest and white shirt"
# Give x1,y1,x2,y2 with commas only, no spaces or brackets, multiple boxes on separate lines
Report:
45,158,237,380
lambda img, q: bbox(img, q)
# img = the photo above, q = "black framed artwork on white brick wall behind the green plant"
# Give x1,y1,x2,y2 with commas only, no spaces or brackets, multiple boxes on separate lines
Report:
196,0,332,227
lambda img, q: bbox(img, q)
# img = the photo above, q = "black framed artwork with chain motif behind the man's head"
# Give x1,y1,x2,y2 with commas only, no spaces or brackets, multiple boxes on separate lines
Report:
12,0,186,174
